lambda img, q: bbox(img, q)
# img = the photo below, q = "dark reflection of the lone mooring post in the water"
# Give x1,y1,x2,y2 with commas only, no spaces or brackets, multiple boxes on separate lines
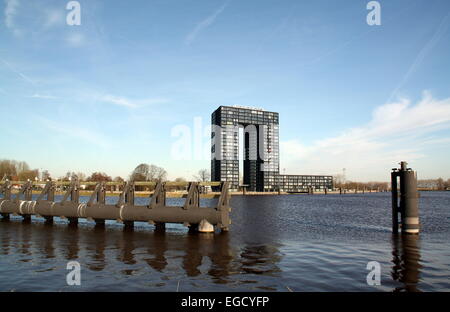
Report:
391,235,422,292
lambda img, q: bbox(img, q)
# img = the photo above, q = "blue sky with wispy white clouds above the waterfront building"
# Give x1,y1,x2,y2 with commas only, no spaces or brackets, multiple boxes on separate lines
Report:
0,0,450,181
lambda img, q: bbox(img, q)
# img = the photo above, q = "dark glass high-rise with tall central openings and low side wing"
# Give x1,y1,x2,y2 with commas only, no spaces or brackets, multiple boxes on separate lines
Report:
211,106,333,192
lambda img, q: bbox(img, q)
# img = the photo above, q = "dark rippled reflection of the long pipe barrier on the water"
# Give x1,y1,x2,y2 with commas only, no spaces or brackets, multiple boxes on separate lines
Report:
0,220,281,290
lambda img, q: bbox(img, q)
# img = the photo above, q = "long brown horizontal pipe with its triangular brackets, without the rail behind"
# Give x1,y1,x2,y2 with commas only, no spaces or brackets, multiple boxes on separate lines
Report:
0,182,231,231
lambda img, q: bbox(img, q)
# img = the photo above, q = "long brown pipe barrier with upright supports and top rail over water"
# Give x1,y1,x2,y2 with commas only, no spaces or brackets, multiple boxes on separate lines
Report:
0,181,231,231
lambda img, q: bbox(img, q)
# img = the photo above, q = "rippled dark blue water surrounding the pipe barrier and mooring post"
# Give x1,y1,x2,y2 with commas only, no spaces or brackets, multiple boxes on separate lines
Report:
0,192,450,291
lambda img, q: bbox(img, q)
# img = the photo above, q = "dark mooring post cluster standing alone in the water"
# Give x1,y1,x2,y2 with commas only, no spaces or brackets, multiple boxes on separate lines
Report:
391,161,420,234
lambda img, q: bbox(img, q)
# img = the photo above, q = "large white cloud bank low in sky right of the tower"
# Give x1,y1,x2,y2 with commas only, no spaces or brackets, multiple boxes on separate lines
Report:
280,92,450,181
